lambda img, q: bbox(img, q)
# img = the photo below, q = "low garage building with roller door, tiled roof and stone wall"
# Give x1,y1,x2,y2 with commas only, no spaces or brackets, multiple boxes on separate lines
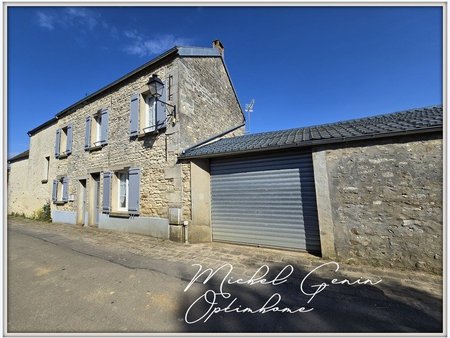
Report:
180,106,443,272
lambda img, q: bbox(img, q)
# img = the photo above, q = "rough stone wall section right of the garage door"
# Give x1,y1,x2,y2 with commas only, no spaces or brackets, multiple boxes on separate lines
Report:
326,134,443,273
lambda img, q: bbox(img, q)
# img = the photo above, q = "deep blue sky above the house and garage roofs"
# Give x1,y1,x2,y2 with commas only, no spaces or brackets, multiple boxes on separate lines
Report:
7,7,442,156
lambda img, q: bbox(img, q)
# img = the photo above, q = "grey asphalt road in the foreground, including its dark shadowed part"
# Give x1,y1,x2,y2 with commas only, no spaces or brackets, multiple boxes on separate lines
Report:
7,220,443,333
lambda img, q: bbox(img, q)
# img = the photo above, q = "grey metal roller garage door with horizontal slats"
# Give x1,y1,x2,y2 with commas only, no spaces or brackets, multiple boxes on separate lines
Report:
211,153,320,252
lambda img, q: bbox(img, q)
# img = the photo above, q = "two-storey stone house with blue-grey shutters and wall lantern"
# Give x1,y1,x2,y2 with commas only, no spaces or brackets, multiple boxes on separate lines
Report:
9,41,245,239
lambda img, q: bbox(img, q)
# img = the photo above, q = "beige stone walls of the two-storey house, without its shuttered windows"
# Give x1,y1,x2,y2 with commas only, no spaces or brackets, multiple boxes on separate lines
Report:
21,43,244,238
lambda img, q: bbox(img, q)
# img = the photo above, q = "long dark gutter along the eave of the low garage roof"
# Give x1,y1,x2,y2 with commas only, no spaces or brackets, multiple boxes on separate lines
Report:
180,126,442,160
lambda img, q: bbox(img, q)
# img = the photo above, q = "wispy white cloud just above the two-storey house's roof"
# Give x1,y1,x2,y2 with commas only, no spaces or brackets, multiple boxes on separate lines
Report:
124,31,190,56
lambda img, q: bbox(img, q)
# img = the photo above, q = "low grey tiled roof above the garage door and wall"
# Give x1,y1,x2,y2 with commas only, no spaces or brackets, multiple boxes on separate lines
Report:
180,105,443,158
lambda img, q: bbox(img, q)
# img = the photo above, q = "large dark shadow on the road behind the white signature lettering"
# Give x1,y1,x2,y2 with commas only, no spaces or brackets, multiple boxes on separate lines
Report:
178,265,443,333
